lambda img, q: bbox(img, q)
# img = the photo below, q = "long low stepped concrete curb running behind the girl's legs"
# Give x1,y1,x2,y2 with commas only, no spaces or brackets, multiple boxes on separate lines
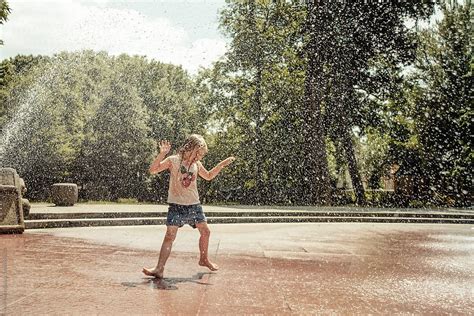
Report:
25,211,474,229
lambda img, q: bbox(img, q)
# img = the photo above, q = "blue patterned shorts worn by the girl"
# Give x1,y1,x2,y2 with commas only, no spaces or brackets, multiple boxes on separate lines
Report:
166,203,207,228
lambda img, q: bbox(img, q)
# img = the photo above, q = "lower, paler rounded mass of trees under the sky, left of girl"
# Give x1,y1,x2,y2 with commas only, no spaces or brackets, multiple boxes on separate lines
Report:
0,51,204,200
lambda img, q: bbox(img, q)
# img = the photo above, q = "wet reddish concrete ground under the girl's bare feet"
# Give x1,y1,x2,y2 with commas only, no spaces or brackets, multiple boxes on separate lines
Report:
0,223,474,315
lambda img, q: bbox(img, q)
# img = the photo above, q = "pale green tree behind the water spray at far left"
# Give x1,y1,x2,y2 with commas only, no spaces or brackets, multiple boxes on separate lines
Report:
0,57,71,198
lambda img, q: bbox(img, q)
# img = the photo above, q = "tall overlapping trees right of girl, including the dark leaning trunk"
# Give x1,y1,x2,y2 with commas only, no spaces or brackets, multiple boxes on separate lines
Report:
213,1,432,203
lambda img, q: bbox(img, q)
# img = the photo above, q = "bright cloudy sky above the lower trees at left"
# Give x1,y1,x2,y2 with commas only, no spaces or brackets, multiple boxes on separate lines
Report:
0,0,228,73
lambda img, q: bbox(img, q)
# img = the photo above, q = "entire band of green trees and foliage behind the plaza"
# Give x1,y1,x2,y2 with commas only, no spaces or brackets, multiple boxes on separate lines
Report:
0,1,466,204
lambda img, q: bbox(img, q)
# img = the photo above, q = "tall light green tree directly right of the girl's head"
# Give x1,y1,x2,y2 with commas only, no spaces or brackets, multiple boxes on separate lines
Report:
213,1,304,203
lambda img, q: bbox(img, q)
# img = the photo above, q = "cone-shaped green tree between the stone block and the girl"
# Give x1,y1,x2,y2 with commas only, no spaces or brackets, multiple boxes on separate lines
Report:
77,78,154,200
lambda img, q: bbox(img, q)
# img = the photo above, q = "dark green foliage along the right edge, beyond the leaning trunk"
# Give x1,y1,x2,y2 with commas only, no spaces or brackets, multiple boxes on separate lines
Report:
368,1,473,205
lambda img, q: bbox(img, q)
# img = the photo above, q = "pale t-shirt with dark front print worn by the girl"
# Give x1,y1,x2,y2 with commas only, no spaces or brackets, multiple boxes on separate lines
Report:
163,155,201,205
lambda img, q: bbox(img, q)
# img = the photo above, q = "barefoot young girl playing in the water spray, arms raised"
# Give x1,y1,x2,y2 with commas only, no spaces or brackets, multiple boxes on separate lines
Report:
143,134,235,278
